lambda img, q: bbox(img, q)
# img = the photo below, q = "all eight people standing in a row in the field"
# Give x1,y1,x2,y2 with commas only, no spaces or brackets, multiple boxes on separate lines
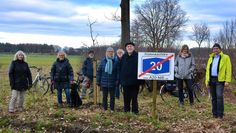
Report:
6,42,232,118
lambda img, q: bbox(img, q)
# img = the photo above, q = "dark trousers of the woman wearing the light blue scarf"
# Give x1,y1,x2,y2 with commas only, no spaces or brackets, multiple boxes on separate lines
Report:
102,87,115,111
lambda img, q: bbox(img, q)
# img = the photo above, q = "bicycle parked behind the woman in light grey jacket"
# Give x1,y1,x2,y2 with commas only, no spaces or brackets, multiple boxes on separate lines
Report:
159,69,205,102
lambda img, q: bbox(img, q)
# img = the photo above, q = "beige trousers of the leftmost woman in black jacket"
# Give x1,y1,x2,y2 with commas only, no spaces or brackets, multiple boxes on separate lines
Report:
9,90,25,112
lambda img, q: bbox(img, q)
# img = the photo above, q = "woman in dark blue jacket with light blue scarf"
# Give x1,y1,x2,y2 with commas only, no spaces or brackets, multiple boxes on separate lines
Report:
97,47,119,111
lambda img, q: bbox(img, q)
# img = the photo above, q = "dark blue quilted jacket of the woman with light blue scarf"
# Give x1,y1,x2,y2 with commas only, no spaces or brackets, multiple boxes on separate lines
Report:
97,58,118,89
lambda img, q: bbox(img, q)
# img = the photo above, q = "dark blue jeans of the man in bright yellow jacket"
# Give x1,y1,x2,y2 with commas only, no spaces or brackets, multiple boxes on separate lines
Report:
210,81,224,117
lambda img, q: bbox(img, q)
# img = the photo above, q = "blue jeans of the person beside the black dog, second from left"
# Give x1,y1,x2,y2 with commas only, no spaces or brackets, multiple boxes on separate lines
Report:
55,82,71,105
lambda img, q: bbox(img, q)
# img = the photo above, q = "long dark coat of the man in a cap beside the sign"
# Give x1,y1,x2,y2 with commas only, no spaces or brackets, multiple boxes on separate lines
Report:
119,51,143,86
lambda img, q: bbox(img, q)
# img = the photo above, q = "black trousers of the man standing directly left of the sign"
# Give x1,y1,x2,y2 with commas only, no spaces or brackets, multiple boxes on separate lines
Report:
123,85,139,114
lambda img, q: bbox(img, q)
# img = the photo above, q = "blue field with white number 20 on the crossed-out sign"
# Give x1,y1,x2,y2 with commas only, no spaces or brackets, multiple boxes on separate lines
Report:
143,58,170,74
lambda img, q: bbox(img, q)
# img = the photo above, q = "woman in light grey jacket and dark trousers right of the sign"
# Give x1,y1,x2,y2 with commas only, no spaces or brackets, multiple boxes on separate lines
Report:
174,45,195,107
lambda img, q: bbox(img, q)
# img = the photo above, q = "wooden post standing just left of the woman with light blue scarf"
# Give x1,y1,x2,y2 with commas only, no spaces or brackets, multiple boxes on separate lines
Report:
93,60,97,104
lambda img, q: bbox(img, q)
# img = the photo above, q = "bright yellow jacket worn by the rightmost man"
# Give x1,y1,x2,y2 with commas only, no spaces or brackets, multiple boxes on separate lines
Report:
205,52,232,85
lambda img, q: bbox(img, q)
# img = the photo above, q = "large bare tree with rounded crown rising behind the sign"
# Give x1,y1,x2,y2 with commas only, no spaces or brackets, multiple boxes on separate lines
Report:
134,0,187,51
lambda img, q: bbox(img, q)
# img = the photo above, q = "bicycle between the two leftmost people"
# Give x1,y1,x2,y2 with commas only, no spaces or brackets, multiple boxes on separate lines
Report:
30,66,50,95
